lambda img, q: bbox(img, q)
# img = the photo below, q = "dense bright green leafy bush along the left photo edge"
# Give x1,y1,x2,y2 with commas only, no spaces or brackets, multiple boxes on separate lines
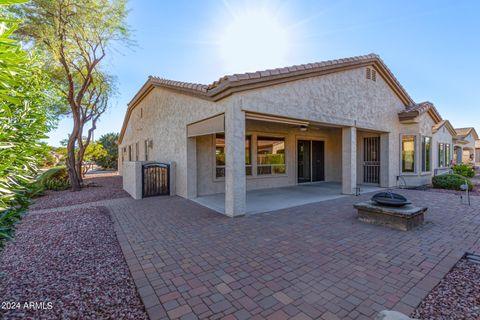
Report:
0,0,55,246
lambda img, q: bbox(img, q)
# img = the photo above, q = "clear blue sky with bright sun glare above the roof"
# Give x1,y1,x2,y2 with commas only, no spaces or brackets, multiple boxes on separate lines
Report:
47,0,480,146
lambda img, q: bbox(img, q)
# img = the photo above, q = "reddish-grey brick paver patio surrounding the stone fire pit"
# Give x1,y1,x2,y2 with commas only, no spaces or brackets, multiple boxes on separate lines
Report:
107,191,480,320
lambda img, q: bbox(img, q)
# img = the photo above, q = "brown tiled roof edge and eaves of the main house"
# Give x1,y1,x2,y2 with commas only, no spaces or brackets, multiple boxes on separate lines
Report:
119,53,415,142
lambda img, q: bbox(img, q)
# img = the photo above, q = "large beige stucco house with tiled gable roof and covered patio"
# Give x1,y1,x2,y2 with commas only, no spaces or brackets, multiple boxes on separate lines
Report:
119,54,459,216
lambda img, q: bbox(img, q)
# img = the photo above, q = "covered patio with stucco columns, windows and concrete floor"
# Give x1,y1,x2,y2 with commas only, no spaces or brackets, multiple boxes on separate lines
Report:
187,110,390,216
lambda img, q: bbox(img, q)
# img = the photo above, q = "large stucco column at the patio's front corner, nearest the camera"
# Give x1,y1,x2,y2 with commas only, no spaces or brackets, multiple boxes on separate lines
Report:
225,103,246,217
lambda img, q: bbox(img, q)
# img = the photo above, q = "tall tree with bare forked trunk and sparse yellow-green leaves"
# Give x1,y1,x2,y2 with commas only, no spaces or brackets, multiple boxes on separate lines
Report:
15,0,129,191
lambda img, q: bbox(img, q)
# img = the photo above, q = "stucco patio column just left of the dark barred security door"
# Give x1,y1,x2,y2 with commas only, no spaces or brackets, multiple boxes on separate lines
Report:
342,127,357,194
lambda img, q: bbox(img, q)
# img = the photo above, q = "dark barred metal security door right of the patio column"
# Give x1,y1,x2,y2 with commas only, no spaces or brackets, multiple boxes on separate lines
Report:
363,137,380,184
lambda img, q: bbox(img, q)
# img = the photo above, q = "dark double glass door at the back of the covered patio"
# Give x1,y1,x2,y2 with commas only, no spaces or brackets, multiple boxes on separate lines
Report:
297,140,325,183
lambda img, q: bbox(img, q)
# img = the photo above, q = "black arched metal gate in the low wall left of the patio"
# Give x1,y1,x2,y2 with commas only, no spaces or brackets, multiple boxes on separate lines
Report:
142,162,170,198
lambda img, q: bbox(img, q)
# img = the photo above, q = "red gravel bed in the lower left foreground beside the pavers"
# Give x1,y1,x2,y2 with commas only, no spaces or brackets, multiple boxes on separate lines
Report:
0,207,148,319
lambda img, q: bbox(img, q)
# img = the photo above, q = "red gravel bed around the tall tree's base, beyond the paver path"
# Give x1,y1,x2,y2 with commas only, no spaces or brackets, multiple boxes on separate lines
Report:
30,173,129,210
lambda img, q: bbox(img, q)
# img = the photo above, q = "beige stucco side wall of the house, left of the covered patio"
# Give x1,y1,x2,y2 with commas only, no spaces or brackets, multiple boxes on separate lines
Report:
120,88,226,197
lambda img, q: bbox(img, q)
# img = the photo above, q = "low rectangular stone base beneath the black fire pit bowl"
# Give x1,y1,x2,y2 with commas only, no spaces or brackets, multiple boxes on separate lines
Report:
354,192,428,231
